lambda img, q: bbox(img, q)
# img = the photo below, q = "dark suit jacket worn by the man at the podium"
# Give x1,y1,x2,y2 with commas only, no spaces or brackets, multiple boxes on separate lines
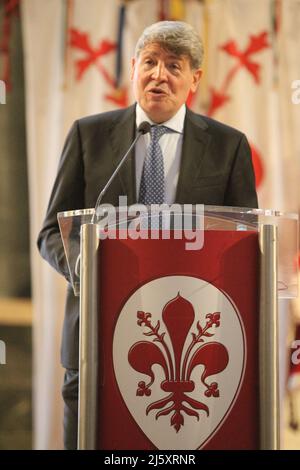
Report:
38,106,257,369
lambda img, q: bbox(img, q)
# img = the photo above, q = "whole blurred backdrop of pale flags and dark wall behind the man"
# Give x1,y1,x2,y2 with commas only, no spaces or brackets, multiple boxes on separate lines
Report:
0,0,300,449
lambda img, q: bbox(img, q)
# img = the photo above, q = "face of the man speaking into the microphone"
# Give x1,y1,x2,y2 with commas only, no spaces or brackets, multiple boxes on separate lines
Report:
131,43,202,124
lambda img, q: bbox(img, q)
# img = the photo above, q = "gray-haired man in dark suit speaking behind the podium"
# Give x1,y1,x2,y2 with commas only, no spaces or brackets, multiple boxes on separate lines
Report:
38,21,257,449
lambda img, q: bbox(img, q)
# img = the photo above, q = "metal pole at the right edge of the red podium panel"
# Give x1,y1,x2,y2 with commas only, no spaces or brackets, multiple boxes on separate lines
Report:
259,225,280,450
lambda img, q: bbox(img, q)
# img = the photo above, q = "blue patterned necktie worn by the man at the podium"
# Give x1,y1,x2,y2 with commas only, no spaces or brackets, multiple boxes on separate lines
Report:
139,126,174,205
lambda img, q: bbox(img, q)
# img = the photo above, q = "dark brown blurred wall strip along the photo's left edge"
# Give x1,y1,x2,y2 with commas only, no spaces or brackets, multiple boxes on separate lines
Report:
0,2,32,449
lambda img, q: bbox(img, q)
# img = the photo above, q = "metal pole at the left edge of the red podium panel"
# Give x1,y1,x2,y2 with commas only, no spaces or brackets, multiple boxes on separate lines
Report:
78,224,99,450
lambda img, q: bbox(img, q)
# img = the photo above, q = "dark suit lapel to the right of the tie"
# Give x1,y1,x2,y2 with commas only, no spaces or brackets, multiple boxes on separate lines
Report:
175,109,211,204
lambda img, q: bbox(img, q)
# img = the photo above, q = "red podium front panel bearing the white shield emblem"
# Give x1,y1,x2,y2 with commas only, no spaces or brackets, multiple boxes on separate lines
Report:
97,230,259,450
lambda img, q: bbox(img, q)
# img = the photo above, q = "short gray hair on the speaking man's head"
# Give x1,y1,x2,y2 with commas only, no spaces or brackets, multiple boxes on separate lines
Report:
135,21,204,69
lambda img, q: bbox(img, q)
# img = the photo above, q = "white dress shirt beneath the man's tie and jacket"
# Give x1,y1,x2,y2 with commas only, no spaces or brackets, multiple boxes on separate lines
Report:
135,104,186,204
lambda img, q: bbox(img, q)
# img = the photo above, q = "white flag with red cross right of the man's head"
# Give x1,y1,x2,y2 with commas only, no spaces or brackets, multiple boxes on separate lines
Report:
206,0,283,208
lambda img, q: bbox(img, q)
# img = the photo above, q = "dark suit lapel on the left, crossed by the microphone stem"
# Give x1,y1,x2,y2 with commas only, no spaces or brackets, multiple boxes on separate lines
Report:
110,105,136,205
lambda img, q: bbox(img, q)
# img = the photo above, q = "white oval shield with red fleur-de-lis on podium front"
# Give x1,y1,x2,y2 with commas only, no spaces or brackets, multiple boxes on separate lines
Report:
113,276,246,449
